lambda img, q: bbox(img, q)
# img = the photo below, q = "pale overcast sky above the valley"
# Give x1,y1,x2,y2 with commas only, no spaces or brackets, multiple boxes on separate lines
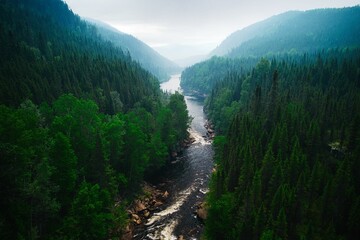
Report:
65,0,360,60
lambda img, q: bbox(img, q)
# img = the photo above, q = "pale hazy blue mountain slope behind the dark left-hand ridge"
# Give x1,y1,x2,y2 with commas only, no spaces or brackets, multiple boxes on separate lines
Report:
86,19,181,82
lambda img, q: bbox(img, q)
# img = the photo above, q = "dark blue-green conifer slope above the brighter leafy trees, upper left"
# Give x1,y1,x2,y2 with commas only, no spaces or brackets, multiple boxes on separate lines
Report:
0,0,159,113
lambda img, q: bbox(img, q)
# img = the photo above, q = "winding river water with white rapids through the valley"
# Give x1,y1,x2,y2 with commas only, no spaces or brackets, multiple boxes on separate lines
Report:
134,75,213,240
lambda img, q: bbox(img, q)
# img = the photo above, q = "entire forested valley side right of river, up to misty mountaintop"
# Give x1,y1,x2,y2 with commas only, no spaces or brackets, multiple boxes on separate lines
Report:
181,6,360,240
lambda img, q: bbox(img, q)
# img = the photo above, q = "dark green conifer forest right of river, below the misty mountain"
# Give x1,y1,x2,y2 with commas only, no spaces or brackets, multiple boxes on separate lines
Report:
206,49,360,240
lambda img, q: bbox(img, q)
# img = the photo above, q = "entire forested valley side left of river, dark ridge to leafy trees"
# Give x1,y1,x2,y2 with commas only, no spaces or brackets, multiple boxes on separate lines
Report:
0,0,189,239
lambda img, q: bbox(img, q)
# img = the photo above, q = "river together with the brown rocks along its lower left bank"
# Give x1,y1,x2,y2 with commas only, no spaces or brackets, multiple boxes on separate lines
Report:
127,75,214,240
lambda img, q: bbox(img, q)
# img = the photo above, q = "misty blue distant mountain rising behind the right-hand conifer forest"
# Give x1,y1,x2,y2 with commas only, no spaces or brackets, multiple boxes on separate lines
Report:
210,6,360,57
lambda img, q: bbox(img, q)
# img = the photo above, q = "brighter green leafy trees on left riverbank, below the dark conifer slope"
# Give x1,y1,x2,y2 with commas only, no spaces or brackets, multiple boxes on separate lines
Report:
0,93,188,239
